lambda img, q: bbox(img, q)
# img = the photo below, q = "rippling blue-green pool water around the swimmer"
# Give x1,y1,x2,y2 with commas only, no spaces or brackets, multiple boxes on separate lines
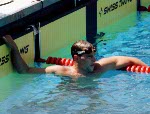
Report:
0,13,150,114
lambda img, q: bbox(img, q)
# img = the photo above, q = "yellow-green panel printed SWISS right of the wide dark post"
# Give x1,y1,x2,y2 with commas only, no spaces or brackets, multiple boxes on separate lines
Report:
97,0,137,32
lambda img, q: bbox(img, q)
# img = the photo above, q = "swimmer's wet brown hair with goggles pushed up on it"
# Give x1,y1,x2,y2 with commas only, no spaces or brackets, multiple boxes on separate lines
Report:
71,40,96,57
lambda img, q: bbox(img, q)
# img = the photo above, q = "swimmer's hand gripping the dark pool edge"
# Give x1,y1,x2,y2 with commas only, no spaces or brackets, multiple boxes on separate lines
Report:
2,35,18,49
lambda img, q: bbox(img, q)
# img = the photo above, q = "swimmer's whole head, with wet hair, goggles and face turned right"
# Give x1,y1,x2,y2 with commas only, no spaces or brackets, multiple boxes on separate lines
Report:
71,40,96,72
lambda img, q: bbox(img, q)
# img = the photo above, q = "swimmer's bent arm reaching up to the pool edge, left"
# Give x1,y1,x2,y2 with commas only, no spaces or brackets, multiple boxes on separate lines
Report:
3,35,66,74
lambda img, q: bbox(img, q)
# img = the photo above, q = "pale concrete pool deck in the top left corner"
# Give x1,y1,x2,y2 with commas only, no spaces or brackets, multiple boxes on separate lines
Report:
0,0,60,27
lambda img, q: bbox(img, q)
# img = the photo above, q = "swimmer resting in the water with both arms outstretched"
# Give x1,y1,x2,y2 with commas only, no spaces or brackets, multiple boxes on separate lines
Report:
3,35,147,78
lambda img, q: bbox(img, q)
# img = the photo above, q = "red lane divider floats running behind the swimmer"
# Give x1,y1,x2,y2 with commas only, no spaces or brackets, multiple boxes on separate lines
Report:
37,57,150,74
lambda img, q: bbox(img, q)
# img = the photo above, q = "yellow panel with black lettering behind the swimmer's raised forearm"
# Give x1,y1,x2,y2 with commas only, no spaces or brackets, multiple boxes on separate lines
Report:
0,33,34,77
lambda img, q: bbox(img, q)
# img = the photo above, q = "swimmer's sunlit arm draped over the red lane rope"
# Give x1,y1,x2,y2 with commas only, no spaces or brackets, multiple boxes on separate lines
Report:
98,56,148,71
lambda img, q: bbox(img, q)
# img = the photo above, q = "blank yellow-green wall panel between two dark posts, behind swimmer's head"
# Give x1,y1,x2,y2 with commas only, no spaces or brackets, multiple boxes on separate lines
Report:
40,7,86,57
